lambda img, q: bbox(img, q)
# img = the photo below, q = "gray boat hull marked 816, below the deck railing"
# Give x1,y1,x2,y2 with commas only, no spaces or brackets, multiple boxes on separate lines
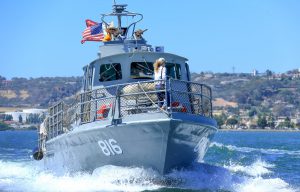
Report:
44,119,217,174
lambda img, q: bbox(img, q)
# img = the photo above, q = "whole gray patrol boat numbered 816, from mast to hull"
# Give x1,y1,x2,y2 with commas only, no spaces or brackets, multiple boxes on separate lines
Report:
33,5,217,174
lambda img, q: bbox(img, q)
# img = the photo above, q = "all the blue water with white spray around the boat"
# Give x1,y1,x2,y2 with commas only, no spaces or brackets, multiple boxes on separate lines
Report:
0,131,300,192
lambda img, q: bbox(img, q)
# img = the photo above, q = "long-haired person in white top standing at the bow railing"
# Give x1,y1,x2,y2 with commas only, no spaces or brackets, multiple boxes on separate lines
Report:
153,58,167,109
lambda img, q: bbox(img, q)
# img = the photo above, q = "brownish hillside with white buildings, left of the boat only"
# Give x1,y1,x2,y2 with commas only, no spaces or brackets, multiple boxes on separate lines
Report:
0,76,82,108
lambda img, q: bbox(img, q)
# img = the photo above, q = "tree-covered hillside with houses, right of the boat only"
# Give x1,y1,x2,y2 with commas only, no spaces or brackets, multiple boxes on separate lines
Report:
192,72,300,116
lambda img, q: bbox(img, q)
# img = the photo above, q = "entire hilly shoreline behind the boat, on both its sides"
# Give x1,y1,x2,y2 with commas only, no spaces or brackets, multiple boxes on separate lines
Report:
0,71,300,116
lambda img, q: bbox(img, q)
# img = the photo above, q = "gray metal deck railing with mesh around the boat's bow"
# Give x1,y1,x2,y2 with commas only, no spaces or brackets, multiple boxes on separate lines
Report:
45,79,212,139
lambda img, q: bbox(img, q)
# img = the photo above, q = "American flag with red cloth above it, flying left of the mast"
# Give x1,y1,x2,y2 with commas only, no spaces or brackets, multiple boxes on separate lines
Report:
81,19,104,43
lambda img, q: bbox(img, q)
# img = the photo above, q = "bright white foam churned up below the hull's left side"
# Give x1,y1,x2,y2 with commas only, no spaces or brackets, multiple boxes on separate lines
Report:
0,161,159,192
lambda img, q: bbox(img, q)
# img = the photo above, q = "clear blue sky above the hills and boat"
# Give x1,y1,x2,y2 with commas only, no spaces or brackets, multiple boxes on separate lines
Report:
0,0,300,78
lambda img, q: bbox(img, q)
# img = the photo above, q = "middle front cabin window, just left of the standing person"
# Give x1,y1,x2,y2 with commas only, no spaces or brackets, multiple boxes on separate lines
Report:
130,62,153,79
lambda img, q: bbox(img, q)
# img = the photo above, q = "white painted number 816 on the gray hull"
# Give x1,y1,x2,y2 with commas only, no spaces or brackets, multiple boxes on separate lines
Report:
98,139,123,156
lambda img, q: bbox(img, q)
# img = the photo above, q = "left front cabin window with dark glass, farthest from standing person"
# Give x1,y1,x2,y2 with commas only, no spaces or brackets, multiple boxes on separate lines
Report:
99,63,122,82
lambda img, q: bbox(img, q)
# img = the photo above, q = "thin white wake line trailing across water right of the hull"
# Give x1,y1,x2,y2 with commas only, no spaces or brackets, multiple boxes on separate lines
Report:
210,142,300,156
